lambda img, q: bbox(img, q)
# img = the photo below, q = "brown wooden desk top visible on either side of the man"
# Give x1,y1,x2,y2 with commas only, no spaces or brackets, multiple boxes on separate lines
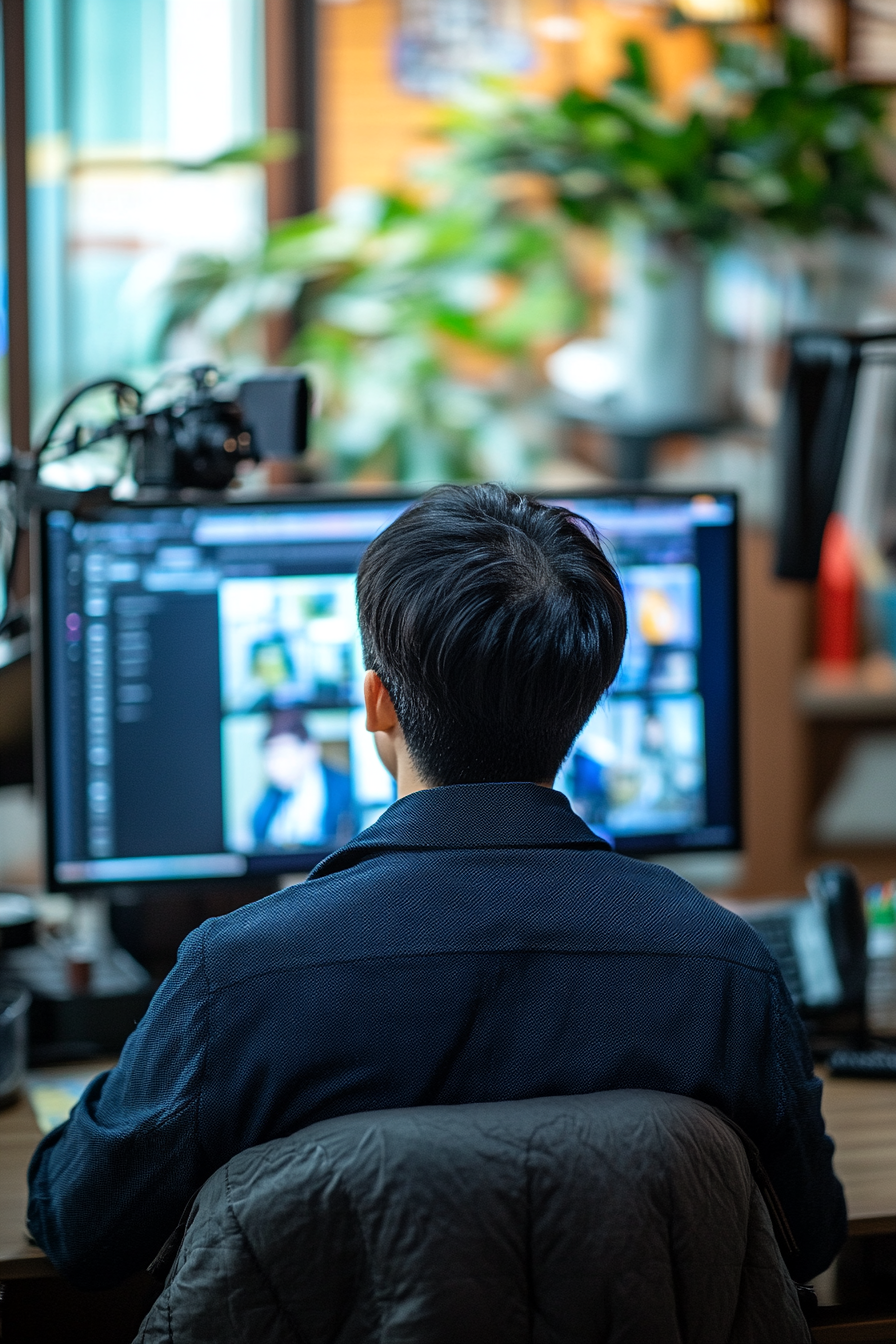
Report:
0,1068,896,1279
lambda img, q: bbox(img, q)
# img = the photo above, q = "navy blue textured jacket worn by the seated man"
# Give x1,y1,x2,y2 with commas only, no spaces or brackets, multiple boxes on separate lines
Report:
28,784,845,1288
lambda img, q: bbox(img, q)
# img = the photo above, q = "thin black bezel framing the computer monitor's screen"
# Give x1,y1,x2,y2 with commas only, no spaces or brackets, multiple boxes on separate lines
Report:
30,482,743,899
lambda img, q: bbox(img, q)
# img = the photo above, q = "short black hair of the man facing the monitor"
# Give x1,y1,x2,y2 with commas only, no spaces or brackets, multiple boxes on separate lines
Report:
357,485,626,785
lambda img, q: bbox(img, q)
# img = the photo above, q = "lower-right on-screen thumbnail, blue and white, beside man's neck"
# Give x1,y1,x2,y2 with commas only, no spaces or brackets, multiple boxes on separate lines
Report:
557,695,705,836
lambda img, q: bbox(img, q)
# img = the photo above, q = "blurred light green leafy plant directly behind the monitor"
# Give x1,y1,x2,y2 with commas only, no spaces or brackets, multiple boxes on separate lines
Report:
169,172,586,481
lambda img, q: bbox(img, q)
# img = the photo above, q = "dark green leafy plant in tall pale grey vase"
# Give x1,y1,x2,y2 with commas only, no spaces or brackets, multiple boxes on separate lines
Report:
451,32,889,423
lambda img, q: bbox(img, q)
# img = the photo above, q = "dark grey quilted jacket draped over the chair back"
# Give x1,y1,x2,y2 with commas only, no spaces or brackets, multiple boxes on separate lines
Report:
137,1091,809,1344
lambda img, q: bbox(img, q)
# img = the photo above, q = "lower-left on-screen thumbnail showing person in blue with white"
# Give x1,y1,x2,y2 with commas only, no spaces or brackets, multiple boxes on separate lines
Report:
222,706,395,853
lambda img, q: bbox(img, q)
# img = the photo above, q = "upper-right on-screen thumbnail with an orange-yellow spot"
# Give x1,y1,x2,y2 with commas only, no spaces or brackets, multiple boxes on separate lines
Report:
614,564,700,692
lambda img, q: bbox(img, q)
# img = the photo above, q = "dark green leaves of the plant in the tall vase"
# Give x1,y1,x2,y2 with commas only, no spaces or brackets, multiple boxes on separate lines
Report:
447,31,888,243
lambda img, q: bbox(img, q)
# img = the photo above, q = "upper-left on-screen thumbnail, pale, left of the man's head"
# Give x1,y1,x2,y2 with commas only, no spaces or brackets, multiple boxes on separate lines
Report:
218,574,363,712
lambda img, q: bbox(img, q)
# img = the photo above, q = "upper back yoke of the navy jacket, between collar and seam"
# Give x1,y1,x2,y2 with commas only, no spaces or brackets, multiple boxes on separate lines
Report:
196,847,775,984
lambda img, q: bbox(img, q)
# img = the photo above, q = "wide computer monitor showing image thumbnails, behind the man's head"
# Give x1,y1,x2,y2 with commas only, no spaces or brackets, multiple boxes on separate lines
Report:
39,492,739,891
